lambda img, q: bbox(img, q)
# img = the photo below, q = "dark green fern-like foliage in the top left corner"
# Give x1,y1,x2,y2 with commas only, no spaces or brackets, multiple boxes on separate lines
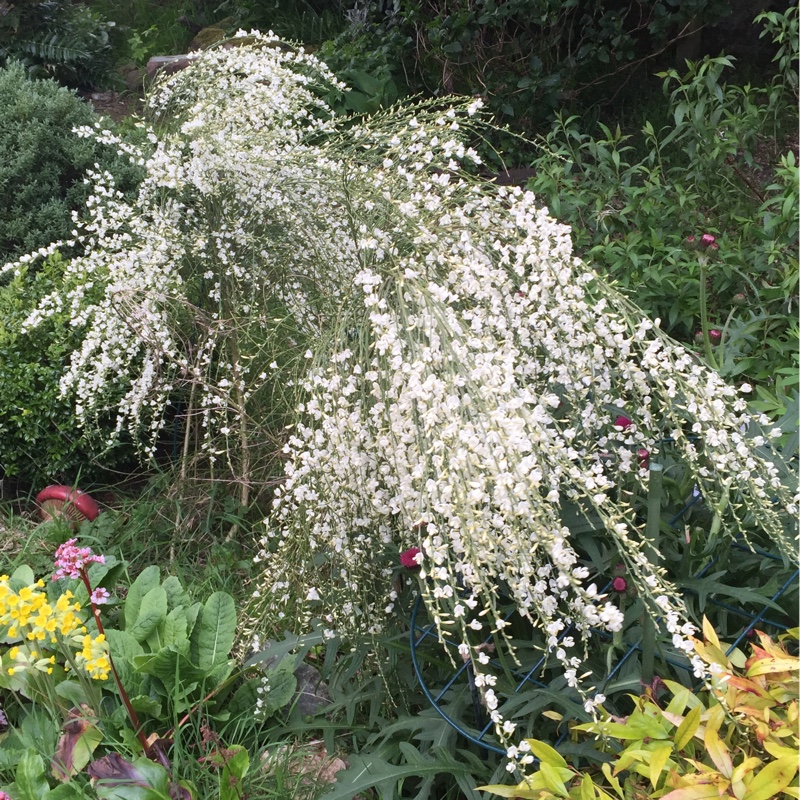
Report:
0,0,119,88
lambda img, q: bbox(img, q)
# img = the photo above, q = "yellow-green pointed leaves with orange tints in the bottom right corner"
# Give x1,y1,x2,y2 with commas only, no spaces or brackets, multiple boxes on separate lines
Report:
481,623,800,800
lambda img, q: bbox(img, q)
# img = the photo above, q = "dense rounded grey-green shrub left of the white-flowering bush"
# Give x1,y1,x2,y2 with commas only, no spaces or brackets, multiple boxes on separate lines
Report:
0,63,141,264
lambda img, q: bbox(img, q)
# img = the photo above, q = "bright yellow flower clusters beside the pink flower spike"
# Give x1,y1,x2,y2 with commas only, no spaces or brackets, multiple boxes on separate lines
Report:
0,575,110,681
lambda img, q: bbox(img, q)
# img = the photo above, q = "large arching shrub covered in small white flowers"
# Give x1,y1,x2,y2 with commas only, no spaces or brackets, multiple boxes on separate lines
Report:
4,35,796,764
